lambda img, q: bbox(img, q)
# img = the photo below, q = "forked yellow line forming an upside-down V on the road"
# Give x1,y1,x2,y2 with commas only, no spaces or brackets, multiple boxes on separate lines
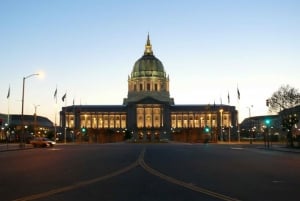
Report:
14,148,238,201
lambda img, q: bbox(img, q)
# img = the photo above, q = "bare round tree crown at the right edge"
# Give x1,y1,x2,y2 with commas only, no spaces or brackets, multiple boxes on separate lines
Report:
267,85,300,112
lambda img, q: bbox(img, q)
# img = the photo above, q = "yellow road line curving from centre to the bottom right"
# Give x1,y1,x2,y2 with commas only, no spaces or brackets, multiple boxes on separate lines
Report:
138,148,238,201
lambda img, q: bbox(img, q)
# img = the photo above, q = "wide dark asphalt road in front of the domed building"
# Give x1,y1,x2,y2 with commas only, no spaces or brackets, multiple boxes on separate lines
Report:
0,143,300,201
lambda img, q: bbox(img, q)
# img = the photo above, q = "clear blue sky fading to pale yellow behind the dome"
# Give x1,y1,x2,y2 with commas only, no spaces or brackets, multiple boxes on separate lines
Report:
0,0,300,122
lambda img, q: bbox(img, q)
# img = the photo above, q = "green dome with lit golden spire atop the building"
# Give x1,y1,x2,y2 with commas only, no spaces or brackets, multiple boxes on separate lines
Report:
131,35,166,78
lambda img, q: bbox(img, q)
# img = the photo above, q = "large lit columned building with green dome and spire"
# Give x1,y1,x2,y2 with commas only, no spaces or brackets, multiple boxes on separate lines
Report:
60,35,237,142
